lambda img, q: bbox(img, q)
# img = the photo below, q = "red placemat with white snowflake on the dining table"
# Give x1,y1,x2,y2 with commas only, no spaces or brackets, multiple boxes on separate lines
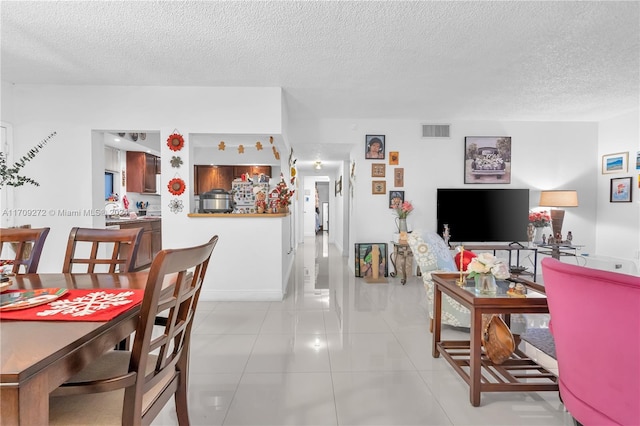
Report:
0,289,144,321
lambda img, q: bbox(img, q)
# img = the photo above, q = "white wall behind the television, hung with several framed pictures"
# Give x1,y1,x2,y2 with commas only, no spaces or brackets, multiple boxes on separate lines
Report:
290,112,640,272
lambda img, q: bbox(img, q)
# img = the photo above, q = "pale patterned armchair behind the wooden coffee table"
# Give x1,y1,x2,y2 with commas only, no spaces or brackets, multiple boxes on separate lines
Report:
407,231,471,331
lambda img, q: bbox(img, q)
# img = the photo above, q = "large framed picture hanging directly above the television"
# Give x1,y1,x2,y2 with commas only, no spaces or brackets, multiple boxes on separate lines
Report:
464,136,511,184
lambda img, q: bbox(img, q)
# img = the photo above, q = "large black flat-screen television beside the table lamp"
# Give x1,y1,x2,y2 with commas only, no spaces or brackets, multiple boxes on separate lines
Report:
436,188,529,243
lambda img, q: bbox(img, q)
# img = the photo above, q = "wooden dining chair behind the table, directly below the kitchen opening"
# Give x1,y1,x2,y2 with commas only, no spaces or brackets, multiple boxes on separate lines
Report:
62,227,142,273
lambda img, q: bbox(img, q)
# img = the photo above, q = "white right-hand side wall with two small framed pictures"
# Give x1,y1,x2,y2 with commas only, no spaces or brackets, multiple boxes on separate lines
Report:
593,111,640,266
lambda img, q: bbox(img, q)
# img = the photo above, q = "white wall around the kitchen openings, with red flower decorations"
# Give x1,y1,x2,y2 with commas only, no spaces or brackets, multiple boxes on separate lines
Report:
1,84,288,278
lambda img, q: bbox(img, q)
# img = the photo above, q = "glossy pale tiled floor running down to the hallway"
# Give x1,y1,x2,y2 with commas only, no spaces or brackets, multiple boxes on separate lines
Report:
153,234,573,426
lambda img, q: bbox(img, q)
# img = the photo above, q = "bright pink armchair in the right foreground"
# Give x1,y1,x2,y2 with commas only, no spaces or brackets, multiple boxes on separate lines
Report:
542,258,640,426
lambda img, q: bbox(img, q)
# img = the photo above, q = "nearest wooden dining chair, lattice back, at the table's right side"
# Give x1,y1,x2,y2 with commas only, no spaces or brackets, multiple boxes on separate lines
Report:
49,235,218,425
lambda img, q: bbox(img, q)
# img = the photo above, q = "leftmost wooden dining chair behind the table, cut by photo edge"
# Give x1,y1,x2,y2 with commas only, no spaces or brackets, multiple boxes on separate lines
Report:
0,228,49,274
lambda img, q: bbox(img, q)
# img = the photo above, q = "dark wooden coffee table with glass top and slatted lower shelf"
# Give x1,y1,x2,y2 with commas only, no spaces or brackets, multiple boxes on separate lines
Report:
431,273,558,407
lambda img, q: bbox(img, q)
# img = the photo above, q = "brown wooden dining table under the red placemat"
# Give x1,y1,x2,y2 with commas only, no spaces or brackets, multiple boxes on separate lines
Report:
0,272,148,426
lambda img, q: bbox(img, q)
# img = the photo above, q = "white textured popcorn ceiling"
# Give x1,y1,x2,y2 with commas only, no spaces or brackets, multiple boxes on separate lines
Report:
0,0,640,171
